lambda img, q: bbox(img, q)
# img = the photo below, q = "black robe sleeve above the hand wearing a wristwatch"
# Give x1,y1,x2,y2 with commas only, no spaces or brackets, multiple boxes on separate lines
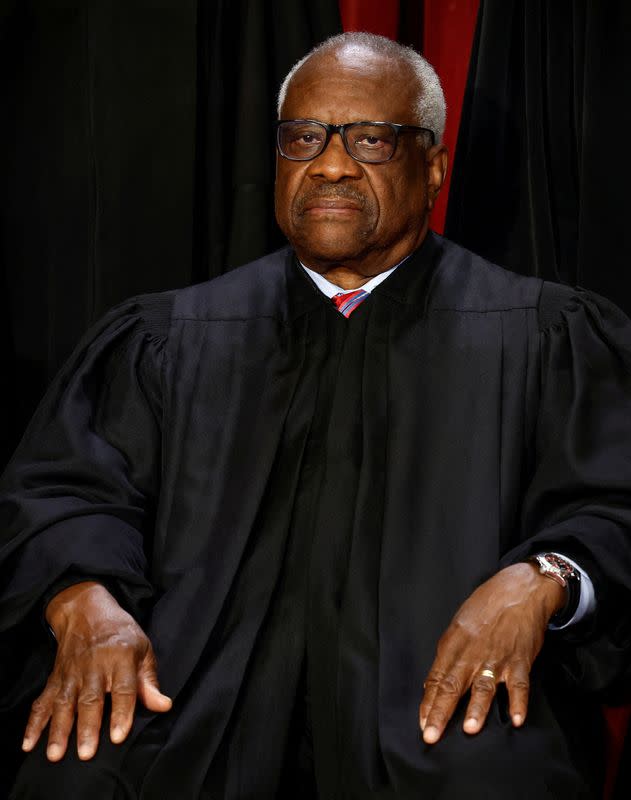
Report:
503,284,631,699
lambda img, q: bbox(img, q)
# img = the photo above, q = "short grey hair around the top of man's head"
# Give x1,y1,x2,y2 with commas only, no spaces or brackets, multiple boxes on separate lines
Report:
277,31,447,143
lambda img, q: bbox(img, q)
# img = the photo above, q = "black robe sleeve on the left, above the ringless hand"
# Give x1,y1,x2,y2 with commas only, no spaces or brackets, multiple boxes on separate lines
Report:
0,294,172,633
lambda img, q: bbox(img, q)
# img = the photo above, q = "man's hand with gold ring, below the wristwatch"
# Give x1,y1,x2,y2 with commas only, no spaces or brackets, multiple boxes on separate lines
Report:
419,563,566,744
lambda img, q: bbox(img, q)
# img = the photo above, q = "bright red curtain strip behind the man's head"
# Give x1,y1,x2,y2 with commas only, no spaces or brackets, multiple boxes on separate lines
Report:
340,0,480,233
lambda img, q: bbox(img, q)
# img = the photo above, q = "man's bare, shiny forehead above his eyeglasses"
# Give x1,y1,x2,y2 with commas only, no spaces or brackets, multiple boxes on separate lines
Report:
282,46,416,124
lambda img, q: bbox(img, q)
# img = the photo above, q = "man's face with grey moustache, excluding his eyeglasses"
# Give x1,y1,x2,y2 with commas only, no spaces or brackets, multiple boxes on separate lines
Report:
276,47,445,276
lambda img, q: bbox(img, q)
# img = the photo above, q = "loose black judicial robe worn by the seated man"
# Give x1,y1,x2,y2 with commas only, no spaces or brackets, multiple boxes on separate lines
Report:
0,234,631,800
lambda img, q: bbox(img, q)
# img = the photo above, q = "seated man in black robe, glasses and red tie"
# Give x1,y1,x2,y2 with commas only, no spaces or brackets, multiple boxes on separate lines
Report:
1,34,631,800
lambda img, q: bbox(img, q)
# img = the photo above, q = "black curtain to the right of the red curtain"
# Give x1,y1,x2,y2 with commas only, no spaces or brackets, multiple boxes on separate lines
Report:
446,0,631,313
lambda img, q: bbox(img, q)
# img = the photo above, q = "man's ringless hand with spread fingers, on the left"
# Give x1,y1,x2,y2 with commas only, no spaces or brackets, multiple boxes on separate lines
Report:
22,581,172,761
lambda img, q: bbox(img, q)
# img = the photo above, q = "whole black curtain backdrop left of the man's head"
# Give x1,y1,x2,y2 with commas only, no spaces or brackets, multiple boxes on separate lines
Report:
0,0,341,472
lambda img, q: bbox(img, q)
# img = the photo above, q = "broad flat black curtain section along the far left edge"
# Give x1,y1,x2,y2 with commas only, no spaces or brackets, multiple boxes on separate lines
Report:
0,0,196,456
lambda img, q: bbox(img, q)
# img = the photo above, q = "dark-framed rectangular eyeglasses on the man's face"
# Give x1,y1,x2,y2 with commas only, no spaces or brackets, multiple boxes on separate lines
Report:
276,119,435,164
